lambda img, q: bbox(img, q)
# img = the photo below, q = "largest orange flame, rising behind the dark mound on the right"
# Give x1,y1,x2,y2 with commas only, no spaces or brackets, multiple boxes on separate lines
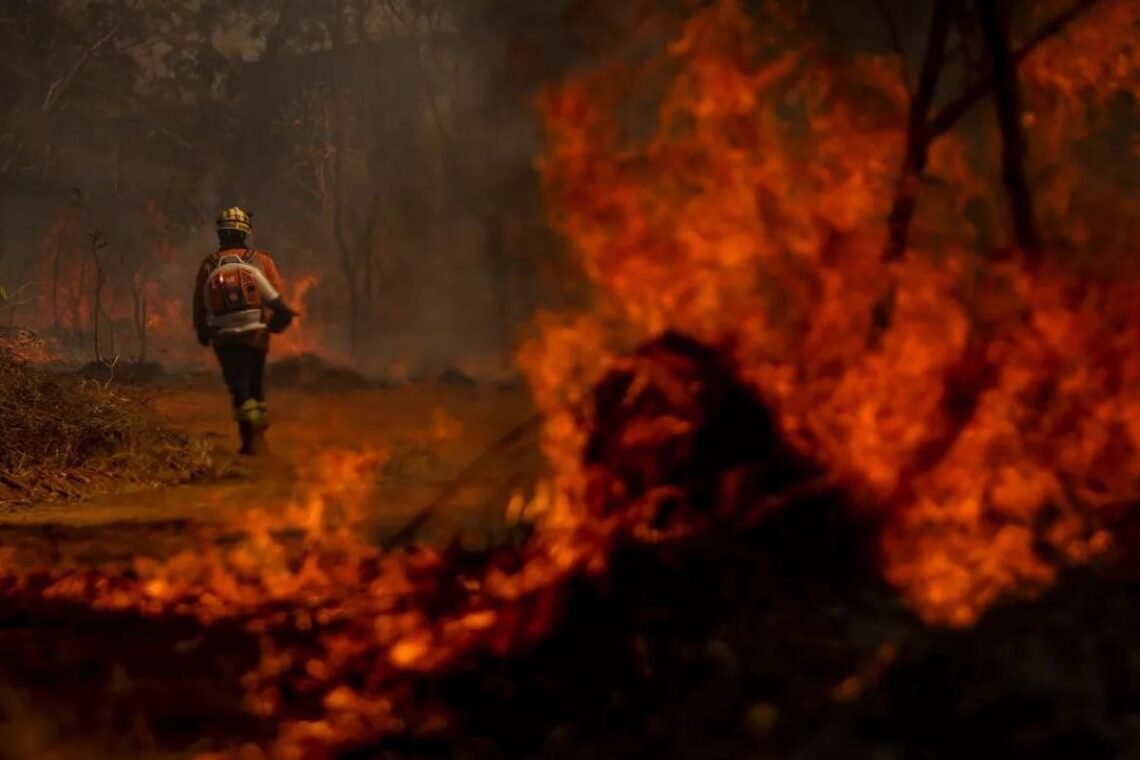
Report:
526,2,1140,624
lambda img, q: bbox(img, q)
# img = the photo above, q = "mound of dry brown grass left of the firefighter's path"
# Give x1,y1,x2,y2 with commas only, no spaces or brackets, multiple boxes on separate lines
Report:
0,351,220,504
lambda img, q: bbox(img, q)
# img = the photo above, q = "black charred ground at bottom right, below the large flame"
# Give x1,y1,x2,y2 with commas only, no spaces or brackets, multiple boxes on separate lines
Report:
380,516,1140,759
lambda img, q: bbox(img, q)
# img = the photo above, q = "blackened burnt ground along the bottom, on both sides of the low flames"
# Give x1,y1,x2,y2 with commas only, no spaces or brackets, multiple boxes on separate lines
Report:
0,489,1140,759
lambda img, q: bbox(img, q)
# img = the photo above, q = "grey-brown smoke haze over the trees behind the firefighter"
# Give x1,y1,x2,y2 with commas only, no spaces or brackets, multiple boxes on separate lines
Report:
0,0,612,374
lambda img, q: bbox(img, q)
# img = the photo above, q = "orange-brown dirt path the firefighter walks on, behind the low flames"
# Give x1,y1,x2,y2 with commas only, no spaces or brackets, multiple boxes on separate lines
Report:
0,384,542,558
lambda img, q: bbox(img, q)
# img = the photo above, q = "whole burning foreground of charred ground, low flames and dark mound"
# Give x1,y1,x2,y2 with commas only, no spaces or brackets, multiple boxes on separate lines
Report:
0,335,1140,760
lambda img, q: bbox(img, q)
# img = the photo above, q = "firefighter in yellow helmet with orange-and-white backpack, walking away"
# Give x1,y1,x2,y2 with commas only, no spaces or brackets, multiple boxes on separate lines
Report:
194,206,295,455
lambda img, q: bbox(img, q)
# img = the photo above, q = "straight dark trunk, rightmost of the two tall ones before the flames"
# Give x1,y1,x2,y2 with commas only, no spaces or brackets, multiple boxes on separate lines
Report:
977,0,1041,261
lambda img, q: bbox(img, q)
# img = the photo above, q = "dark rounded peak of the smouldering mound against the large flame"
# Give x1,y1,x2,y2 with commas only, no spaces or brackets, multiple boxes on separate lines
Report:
584,333,822,538
